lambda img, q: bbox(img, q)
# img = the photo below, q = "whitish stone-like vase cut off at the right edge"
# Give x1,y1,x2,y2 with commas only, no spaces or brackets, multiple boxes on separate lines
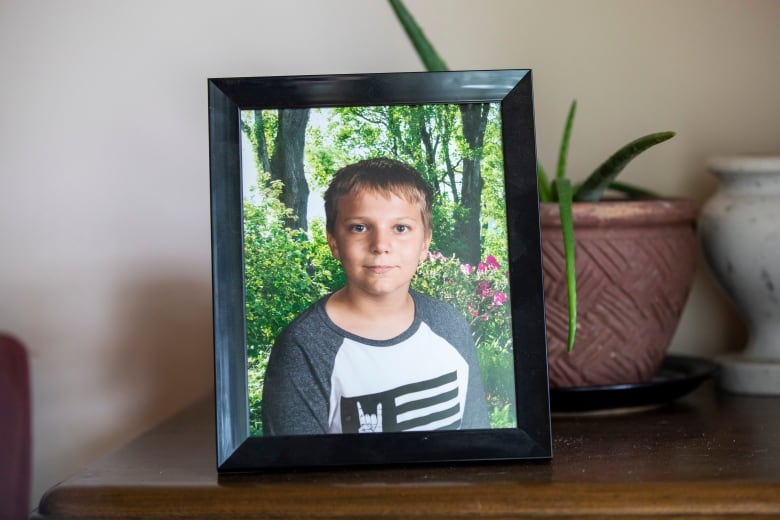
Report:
699,156,780,395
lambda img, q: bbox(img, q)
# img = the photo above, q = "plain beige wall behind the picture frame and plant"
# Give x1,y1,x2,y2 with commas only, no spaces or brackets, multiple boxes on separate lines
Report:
0,0,780,512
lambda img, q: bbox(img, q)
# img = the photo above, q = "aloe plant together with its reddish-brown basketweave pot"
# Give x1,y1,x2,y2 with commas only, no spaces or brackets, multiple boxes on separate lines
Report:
389,0,697,387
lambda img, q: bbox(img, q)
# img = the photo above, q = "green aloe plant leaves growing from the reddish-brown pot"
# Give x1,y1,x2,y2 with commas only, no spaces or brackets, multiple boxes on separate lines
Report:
388,0,675,351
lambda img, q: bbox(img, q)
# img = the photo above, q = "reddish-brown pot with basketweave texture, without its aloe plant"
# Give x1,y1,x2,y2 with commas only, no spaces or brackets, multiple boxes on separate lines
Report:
540,200,698,387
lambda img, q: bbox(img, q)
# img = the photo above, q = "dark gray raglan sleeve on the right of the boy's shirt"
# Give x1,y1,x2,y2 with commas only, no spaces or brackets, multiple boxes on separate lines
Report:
414,293,490,429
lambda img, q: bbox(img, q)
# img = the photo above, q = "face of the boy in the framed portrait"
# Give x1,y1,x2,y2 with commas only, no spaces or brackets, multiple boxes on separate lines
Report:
328,191,431,297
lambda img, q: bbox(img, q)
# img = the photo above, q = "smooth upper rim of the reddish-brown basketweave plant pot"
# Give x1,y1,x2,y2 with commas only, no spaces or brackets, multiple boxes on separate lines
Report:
539,198,699,229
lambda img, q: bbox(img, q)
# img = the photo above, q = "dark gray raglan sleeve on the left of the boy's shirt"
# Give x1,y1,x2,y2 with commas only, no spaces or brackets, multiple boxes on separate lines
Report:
262,304,334,435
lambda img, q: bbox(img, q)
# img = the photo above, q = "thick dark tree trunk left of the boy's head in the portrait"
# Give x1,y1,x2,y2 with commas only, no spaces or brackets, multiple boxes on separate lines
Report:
270,108,309,230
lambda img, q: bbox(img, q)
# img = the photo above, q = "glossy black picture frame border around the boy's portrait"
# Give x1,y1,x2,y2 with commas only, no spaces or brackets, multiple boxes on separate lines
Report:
208,69,552,473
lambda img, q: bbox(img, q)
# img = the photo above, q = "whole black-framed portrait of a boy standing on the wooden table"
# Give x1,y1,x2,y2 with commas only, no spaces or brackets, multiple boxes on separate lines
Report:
208,70,552,472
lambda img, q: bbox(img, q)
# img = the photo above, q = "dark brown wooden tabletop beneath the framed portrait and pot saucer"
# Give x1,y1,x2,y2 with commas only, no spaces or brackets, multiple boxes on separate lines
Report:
34,383,780,520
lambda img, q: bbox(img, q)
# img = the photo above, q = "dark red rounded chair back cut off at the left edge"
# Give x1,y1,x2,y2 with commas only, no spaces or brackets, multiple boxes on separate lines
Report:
0,332,31,520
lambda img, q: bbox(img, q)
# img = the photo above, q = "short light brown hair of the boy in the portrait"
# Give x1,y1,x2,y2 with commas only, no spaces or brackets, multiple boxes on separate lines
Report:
325,157,433,233
